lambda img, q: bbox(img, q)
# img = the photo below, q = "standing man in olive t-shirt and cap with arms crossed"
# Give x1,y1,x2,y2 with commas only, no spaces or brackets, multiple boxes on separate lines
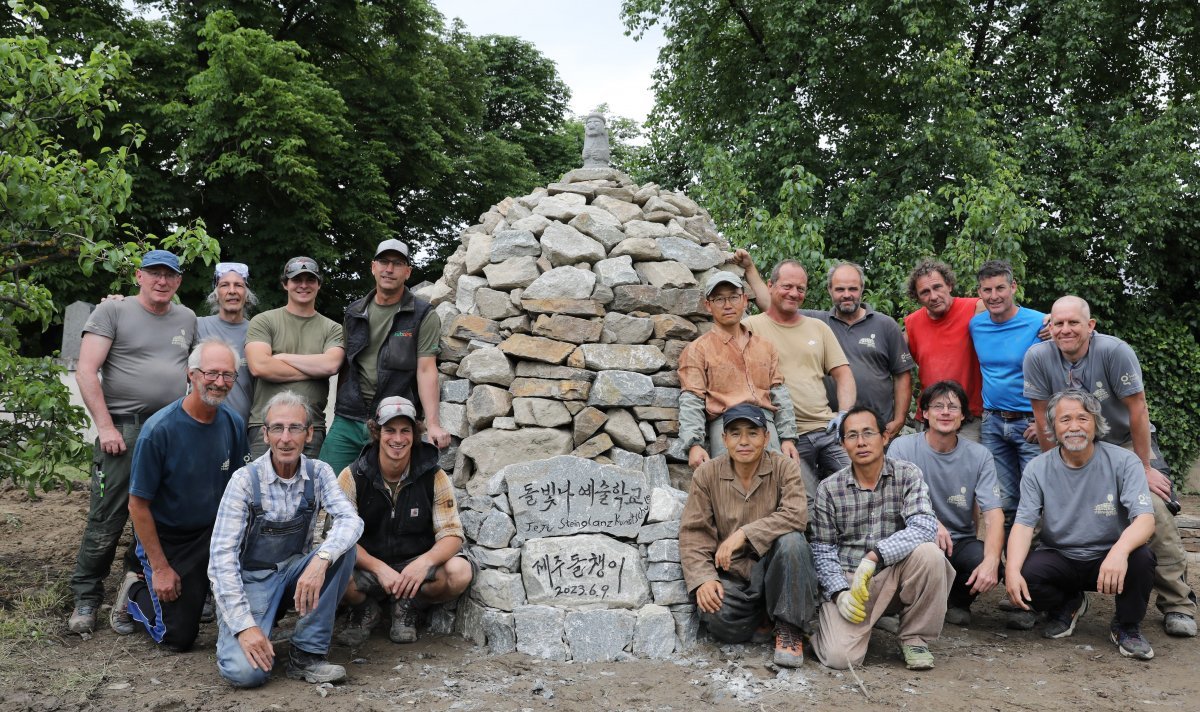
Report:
246,257,346,457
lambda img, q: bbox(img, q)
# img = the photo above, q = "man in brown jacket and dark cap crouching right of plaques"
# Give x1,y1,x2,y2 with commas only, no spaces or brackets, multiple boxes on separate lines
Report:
679,403,817,668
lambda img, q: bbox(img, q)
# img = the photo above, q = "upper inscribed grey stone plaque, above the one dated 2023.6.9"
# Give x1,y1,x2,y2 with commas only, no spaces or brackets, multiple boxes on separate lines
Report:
503,455,650,539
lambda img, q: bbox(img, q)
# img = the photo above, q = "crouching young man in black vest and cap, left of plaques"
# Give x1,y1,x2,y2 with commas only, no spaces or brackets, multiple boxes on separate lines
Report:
337,396,475,646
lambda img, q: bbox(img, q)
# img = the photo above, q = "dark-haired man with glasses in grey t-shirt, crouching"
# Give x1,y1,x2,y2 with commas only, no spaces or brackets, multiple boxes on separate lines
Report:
888,381,1004,626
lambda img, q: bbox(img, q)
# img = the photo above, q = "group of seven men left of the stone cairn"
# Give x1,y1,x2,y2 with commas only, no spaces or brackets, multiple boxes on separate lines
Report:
68,239,475,687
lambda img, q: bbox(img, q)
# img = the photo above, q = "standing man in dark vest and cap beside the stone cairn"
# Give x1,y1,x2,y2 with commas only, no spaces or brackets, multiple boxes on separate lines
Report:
320,240,450,472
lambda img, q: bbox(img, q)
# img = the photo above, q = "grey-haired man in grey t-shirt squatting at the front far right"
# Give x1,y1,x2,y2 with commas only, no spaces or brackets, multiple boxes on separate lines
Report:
1004,388,1154,660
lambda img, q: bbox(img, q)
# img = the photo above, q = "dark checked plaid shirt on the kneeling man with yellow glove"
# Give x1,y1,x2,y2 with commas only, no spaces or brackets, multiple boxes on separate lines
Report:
812,457,937,600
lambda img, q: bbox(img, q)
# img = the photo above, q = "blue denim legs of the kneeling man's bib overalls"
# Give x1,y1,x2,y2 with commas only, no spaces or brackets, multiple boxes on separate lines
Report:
217,548,356,687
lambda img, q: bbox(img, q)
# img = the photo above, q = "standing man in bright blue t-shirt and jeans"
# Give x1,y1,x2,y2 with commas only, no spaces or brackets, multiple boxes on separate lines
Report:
970,259,1045,526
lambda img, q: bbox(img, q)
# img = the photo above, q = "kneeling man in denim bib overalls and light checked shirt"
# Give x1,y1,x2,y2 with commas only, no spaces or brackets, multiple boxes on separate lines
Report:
209,390,362,687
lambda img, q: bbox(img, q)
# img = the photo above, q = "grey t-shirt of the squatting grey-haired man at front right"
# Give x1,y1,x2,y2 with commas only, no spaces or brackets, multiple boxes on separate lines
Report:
1016,443,1154,561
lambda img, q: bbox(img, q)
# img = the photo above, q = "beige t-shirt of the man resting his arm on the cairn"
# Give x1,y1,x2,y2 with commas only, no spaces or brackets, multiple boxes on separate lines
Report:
742,313,850,435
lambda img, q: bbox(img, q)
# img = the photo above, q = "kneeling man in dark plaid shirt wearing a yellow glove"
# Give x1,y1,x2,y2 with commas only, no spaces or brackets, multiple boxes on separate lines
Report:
812,407,954,670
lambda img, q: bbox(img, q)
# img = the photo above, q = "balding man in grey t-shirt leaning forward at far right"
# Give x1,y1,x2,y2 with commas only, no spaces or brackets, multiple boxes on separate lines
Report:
1022,291,1196,638
